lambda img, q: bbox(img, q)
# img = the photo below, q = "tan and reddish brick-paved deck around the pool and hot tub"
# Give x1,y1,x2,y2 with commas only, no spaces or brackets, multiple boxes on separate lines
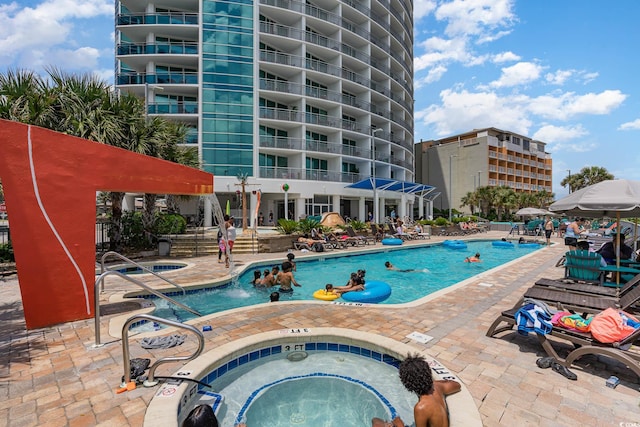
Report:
0,232,640,427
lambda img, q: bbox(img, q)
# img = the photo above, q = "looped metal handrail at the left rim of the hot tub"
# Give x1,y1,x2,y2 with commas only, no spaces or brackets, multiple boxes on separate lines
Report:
122,314,204,387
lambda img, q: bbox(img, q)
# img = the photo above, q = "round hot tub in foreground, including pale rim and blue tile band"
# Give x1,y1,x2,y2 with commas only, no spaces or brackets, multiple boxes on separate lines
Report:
144,328,482,427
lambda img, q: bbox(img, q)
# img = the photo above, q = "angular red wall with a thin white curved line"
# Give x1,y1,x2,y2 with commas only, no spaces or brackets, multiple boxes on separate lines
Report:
0,120,213,329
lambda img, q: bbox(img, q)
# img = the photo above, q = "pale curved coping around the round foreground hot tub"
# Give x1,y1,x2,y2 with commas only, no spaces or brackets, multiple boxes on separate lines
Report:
143,327,482,427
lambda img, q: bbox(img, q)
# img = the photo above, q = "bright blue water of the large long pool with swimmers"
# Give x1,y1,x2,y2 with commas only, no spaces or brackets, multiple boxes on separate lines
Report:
139,241,542,321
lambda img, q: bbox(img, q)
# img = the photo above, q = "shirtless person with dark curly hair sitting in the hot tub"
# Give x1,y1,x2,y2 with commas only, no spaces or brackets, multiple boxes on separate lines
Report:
394,354,461,427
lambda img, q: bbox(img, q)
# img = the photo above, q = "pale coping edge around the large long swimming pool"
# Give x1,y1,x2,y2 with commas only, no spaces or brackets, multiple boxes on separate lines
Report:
108,238,543,339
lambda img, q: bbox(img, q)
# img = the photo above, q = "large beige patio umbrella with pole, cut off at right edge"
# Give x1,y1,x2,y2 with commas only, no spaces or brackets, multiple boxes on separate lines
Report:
549,179,640,292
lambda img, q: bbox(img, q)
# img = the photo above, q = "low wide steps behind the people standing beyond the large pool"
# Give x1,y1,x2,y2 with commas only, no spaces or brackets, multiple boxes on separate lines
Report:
170,229,258,258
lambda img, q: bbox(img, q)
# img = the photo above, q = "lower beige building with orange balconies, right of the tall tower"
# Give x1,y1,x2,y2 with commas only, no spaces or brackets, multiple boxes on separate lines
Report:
415,128,552,214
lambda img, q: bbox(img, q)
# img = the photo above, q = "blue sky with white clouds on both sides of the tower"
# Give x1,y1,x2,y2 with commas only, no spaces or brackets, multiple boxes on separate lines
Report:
0,0,640,197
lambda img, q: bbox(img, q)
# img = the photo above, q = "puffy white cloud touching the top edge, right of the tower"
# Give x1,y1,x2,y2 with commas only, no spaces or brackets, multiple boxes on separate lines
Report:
435,0,516,38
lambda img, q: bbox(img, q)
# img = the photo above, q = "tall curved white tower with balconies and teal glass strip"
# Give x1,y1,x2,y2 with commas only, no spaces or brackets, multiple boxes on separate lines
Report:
115,0,414,226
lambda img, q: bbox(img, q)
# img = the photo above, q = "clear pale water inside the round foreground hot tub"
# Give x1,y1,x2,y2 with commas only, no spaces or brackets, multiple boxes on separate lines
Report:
210,351,416,427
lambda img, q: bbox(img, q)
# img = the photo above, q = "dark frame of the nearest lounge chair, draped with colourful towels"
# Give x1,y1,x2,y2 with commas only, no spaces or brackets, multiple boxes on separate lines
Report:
486,298,640,377
